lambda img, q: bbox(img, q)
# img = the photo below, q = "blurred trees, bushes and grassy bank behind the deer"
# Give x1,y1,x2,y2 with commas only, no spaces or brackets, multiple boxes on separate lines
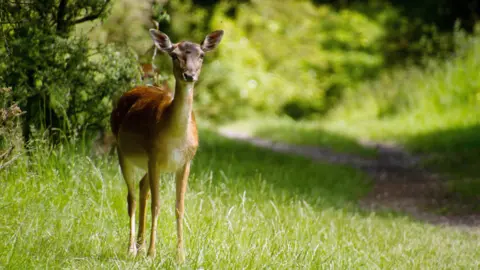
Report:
0,0,480,196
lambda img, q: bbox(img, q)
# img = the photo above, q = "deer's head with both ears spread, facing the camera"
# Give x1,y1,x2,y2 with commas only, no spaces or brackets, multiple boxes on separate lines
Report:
150,29,223,82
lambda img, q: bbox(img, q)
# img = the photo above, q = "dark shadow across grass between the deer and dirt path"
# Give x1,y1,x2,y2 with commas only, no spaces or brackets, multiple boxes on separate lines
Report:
192,130,371,210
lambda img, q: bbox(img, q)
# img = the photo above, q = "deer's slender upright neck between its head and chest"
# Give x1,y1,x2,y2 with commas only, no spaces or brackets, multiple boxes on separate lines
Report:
166,81,194,137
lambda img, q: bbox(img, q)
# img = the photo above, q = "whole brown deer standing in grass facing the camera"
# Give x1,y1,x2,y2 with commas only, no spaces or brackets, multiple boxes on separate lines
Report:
110,29,224,262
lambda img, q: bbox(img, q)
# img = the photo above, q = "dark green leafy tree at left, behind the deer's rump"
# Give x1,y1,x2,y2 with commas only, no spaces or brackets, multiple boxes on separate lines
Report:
0,1,138,139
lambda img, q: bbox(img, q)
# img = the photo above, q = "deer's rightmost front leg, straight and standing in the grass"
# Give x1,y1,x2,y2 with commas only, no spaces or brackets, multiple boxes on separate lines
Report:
175,162,190,262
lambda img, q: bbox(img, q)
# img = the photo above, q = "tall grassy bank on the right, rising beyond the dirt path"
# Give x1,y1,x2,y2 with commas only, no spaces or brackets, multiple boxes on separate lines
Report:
322,28,480,181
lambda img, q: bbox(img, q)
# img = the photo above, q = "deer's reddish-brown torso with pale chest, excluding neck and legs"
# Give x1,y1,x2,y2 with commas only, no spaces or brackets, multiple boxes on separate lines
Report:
111,86,198,171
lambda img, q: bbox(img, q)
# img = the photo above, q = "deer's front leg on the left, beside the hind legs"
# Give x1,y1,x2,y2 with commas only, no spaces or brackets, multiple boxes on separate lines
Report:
148,158,160,257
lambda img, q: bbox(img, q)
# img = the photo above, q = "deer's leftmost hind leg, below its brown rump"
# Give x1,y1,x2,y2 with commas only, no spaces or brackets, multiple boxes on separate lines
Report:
117,150,137,255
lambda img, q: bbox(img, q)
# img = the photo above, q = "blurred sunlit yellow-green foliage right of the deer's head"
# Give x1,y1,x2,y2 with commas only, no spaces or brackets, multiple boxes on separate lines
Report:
193,1,478,119
